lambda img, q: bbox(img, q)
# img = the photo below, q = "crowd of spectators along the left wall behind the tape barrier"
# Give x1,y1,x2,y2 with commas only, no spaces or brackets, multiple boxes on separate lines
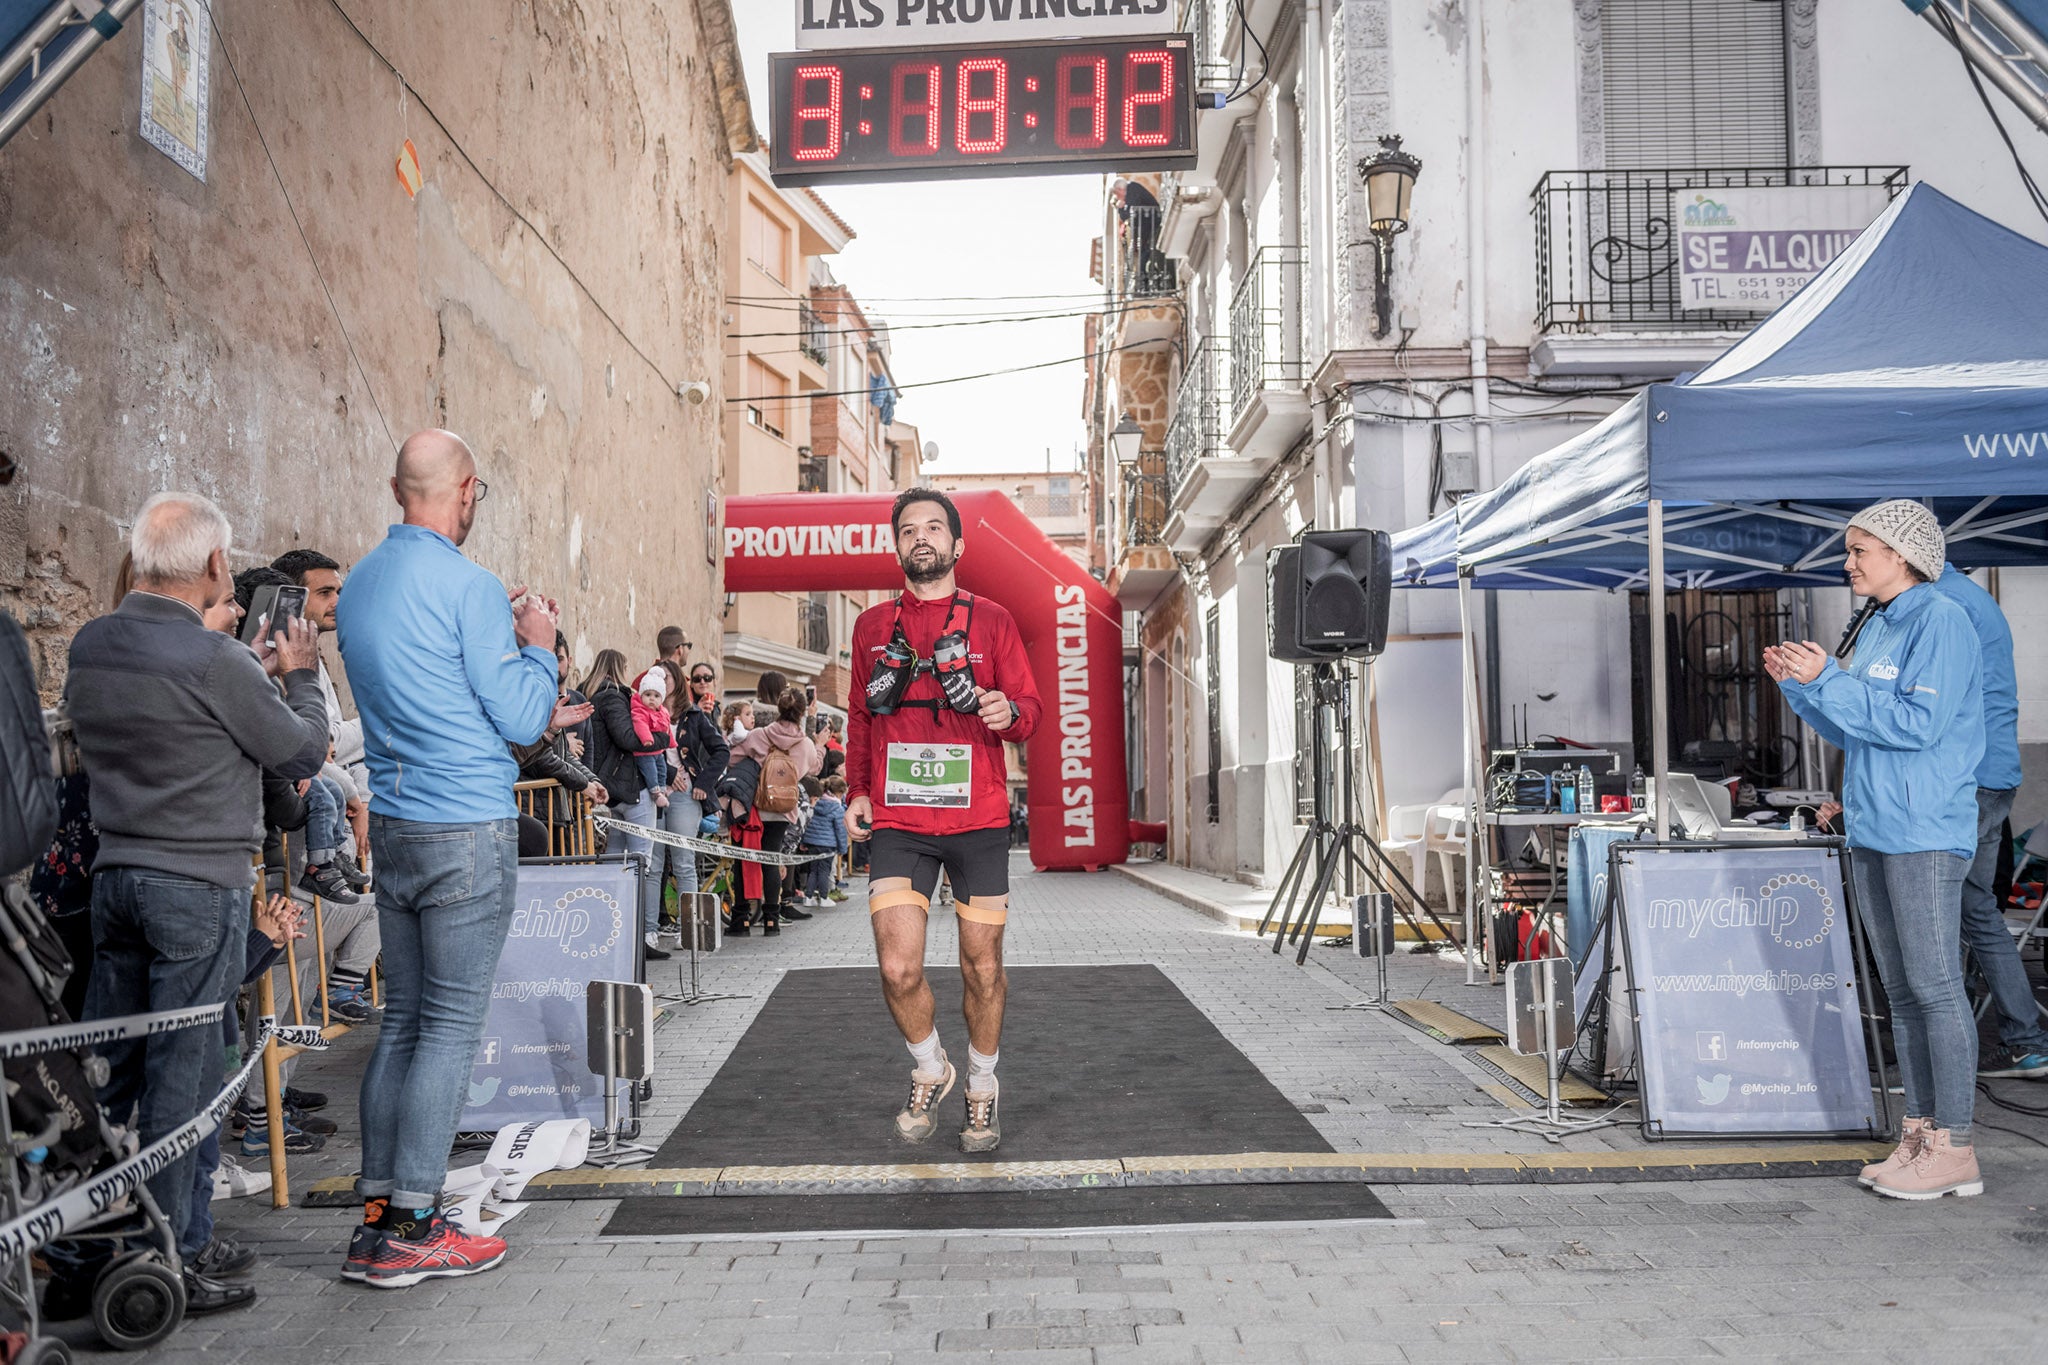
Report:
8,466,848,1320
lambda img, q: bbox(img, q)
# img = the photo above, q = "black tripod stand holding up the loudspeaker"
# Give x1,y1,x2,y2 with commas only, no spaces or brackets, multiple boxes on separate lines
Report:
1257,661,1456,964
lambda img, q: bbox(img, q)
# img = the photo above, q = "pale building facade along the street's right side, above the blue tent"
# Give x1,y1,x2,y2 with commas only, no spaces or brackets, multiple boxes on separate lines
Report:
1087,0,2048,884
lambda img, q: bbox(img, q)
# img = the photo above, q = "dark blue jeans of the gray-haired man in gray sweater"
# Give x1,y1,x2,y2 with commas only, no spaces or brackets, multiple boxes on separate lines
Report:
86,868,250,1268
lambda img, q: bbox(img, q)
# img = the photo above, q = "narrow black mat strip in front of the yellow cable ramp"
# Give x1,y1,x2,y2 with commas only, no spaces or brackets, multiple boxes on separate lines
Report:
604,1183,1393,1238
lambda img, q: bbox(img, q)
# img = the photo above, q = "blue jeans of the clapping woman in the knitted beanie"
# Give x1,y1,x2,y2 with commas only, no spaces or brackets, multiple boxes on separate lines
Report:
1849,849,1976,1146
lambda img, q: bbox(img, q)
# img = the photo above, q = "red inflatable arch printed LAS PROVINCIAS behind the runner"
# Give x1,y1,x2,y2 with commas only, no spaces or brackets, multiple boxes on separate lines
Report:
725,489,1130,870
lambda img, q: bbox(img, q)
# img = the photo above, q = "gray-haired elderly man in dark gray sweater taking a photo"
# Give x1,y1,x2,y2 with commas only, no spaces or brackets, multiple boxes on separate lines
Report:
51,493,328,1316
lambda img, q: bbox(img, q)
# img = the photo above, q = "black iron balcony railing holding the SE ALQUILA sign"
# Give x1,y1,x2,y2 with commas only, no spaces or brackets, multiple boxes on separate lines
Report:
1530,166,1907,332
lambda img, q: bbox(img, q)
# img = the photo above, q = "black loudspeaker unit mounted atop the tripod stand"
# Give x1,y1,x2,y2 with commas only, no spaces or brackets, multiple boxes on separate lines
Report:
1268,530,1393,663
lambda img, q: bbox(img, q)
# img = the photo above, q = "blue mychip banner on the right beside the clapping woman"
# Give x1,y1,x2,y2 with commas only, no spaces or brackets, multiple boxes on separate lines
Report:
1616,843,1880,1136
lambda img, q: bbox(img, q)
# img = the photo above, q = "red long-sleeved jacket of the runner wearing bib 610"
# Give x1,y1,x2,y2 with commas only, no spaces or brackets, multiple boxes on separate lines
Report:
846,591,1044,835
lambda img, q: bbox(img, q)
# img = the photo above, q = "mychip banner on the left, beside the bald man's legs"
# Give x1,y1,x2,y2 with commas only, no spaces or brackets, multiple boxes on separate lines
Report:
461,862,639,1132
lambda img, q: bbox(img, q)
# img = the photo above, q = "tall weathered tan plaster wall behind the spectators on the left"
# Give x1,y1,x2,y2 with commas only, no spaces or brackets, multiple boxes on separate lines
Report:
0,0,752,696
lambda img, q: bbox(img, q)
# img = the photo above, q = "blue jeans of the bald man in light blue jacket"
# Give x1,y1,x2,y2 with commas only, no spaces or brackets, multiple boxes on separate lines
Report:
356,810,518,1209
